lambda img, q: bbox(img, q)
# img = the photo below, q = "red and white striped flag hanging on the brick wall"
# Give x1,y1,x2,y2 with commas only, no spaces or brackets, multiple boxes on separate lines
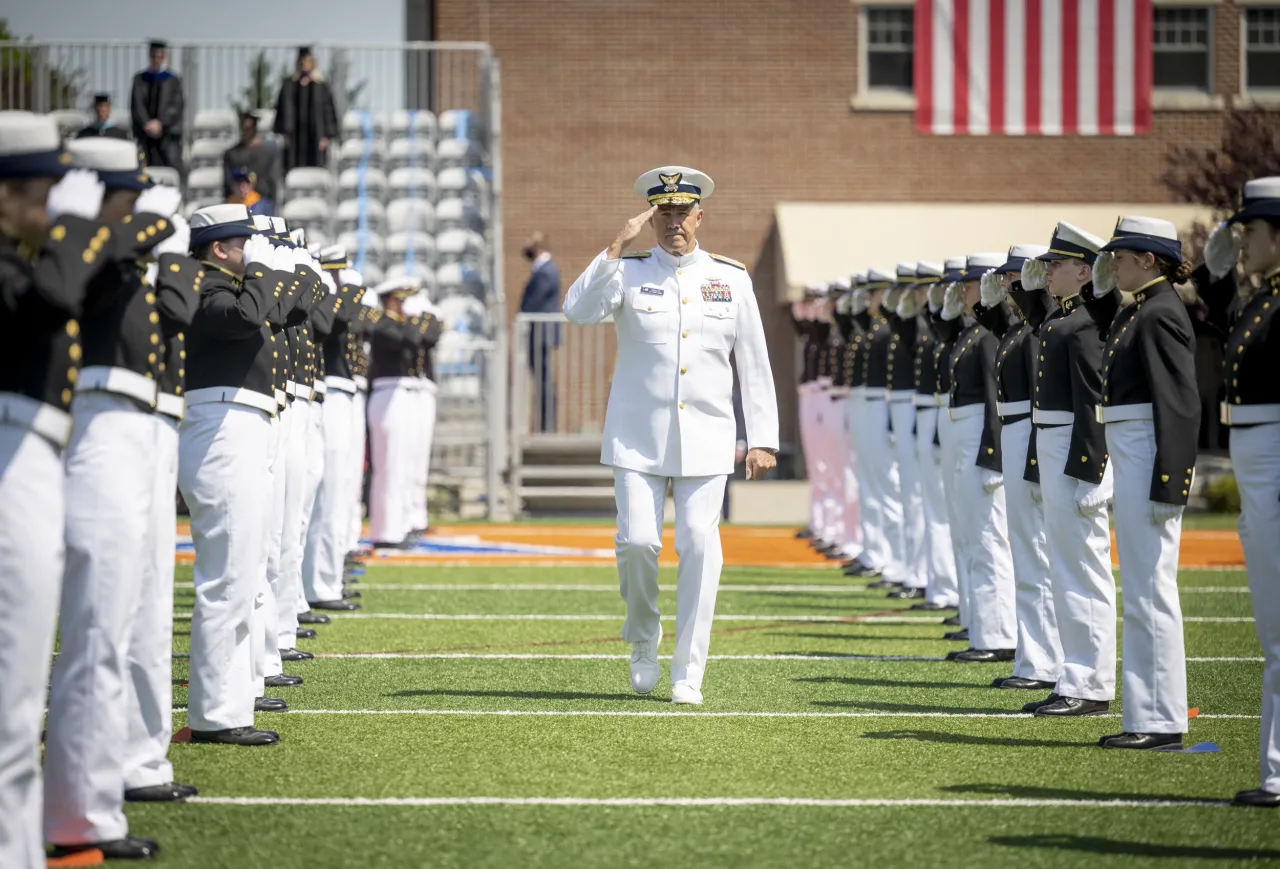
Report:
915,0,1152,136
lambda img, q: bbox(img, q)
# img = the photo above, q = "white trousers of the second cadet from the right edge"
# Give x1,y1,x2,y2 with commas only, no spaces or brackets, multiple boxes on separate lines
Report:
1106,420,1187,733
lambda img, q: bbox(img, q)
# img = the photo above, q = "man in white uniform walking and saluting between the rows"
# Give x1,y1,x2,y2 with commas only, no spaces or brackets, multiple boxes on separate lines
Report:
564,166,778,704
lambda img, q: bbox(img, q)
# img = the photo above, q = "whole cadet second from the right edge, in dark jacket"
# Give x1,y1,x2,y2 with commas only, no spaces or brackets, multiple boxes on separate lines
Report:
1084,216,1199,749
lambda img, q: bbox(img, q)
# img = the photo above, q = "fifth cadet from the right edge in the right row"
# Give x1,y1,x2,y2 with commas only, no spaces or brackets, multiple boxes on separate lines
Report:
942,253,1018,663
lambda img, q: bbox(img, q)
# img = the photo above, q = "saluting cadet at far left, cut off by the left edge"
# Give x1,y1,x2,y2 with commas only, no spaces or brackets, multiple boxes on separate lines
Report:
0,111,111,869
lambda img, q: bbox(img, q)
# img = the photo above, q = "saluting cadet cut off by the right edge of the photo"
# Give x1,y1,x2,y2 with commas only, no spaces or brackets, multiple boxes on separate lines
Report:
1198,177,1280,809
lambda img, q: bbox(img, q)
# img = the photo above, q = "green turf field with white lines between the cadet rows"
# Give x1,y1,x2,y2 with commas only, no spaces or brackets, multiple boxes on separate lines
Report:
137,567,1280,869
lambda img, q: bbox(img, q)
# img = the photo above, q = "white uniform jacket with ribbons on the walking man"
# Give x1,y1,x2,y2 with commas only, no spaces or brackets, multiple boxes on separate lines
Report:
564,247,778,477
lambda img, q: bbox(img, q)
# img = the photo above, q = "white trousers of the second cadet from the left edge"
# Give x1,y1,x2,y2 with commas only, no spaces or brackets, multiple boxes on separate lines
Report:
45,393,156,845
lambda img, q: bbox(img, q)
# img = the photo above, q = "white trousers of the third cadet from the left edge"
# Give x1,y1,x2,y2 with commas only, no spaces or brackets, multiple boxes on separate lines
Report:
124,413,178,790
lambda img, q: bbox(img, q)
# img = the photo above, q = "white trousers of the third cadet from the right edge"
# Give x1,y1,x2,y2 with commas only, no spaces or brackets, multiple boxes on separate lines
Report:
1036,425,1116,700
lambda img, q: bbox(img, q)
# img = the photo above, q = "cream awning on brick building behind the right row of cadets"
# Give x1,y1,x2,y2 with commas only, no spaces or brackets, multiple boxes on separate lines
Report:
774,202,1212,303
